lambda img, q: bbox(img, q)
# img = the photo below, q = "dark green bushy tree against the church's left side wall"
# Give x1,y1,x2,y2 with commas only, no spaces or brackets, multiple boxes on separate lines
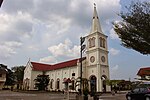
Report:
34,74,50,90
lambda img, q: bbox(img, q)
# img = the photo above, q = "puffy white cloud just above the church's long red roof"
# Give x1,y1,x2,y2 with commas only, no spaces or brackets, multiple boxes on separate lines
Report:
40,39,80,63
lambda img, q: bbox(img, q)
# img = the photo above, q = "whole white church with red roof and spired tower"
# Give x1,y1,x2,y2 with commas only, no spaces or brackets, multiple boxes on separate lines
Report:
23,7,110,92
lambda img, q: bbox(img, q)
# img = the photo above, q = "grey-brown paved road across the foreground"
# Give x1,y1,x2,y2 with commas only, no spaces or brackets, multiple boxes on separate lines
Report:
0,90,126,100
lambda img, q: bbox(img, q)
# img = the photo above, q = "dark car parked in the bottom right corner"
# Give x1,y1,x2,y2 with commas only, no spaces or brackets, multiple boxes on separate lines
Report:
126,85,150,100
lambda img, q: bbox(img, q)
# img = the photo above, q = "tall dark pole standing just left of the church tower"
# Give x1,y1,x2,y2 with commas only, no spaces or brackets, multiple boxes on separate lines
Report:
80,37,85,95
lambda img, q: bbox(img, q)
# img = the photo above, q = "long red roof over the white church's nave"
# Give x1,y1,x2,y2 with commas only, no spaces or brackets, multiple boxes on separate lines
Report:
31,57,86,71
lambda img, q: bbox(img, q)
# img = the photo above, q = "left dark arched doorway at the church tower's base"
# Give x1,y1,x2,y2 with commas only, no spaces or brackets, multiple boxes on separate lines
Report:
90,75,97,92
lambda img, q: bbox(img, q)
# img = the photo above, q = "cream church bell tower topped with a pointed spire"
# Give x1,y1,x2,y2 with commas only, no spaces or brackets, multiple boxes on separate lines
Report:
86,5,109,92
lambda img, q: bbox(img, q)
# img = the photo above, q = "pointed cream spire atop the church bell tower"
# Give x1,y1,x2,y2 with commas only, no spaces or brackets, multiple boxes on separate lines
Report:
91,3,102,33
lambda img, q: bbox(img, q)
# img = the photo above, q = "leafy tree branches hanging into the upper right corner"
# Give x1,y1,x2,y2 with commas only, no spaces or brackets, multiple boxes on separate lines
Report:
113,1,150,55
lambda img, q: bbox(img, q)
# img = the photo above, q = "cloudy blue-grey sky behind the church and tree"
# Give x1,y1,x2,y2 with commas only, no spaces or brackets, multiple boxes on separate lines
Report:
0,0,150,80
